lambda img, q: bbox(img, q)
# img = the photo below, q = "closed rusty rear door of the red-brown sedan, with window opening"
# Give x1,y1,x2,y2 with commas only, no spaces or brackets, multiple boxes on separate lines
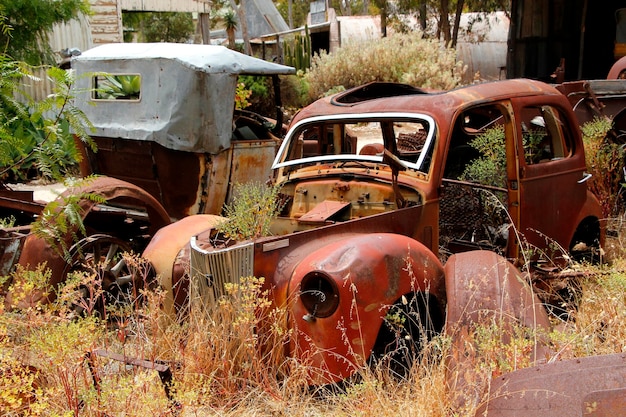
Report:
513,97,588,263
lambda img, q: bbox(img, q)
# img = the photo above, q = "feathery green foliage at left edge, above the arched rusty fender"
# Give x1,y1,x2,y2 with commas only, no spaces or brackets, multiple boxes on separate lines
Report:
0,61,95,181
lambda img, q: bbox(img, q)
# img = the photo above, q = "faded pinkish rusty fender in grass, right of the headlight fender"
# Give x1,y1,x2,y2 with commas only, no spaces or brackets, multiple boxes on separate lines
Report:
444,250,551,405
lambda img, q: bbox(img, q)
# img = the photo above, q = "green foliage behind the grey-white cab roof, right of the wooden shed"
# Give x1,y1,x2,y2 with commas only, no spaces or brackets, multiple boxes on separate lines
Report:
122,12,195,43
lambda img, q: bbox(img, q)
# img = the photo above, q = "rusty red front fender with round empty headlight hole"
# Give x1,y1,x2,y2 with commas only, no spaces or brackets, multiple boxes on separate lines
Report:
288,233,445,384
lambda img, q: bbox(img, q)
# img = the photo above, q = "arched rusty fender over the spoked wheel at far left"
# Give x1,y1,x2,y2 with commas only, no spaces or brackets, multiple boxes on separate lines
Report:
5,177,170,307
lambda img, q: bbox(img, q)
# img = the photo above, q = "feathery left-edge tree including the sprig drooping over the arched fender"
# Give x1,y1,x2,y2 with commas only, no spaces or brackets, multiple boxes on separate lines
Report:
0,11,103,255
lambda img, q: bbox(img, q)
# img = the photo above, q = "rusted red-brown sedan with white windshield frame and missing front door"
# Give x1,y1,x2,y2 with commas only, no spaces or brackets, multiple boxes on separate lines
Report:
144,80,604,383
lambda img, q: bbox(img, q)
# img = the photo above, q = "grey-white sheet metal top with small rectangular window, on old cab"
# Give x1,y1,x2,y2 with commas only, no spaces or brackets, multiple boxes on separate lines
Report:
72,43,295,154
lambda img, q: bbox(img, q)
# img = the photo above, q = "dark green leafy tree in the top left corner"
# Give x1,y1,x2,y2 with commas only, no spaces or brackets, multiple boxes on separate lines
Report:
0,0,90,65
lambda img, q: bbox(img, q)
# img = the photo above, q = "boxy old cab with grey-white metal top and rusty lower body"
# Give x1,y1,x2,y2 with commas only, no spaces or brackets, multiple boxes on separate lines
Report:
72,43,295,219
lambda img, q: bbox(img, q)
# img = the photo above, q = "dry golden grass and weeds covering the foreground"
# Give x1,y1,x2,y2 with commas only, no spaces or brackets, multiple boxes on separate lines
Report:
0,244,626,417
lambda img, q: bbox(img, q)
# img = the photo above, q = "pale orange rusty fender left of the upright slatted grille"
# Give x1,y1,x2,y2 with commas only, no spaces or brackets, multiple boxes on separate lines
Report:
143,214,226,318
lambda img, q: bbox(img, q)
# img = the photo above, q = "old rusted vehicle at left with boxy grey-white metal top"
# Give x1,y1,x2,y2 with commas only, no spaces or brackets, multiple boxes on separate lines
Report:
0,43,295,303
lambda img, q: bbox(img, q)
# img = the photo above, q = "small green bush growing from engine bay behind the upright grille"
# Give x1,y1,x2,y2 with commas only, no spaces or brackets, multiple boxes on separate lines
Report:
217,183,282,241
